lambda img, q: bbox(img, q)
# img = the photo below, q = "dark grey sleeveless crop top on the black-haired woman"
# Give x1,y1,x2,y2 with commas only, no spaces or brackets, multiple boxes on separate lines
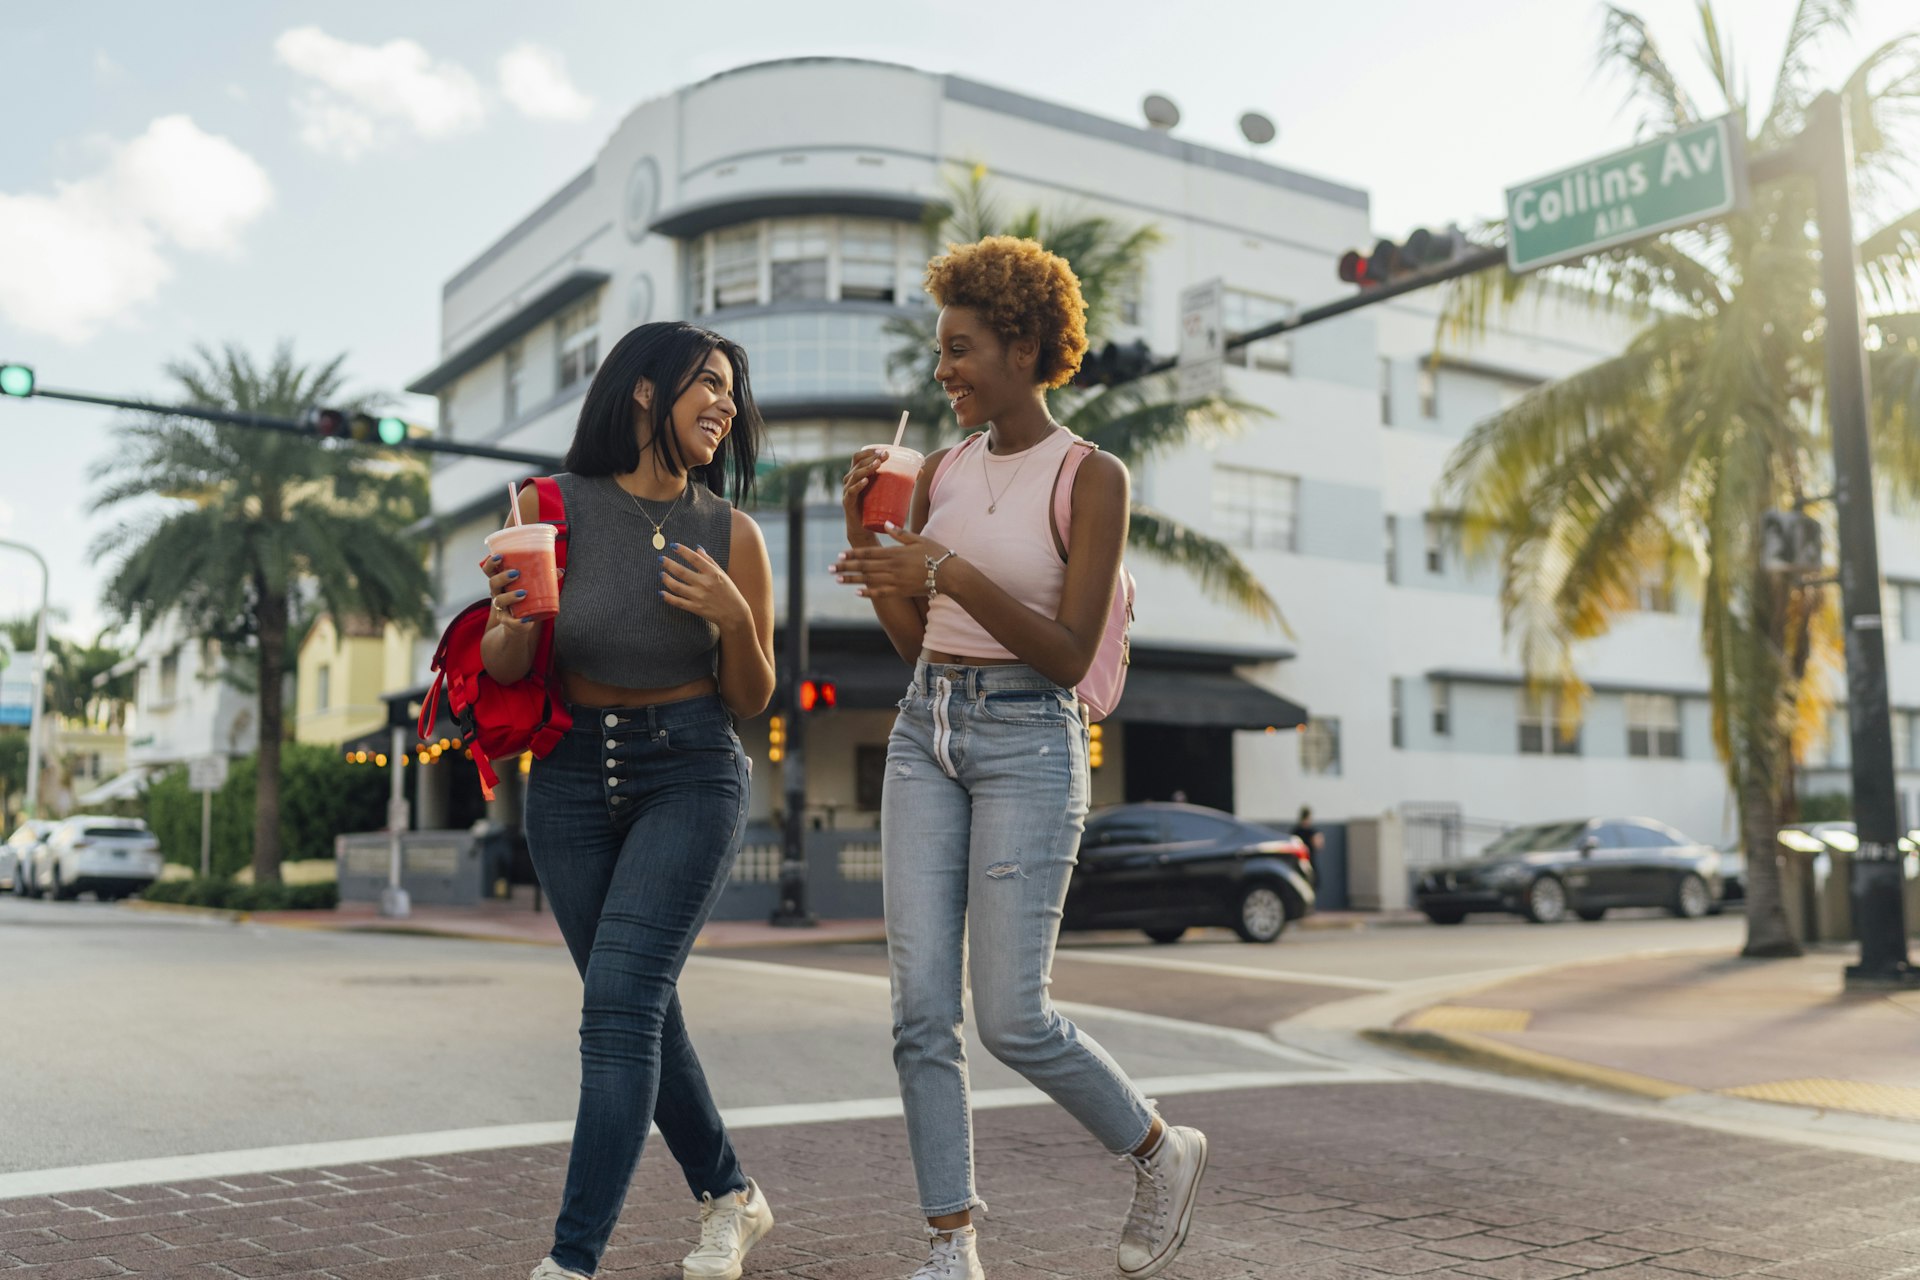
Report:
553,472,733,689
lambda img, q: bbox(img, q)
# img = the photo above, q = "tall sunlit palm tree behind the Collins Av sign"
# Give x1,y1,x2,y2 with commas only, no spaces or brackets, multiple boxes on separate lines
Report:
1442,0,1920,956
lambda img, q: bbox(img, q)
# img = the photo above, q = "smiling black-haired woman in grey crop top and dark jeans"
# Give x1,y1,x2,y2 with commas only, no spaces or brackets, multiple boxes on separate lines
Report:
482,322,774,1280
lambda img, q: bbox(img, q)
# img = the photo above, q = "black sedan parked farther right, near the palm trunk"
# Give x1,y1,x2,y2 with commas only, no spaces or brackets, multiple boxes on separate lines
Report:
1415,818,1720,925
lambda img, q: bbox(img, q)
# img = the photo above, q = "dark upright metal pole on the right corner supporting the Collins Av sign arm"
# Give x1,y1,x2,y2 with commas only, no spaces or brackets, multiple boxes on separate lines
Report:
1799,94,1920,988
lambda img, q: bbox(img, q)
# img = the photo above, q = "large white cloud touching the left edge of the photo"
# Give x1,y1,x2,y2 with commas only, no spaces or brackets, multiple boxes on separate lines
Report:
0,115,273,342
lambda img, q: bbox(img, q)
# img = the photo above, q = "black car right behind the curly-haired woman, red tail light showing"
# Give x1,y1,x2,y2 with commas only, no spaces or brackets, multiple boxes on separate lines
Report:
1062,804,1313,942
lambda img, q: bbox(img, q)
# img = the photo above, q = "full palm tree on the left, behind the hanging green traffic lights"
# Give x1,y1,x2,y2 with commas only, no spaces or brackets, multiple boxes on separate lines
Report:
94,345,428,883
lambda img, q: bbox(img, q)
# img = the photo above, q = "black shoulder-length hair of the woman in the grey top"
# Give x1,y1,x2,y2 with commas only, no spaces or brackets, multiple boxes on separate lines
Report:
566,320,760,507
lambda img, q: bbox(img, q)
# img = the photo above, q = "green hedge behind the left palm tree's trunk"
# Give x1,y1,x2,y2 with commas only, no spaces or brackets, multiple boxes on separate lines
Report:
142,743,388,877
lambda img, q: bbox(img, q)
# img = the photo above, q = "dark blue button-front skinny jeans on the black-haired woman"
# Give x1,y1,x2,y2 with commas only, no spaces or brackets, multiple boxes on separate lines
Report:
526,695,747,1274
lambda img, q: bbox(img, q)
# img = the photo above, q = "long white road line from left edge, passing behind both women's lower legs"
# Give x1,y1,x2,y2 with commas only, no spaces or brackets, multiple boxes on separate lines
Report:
0,1069,1407,1201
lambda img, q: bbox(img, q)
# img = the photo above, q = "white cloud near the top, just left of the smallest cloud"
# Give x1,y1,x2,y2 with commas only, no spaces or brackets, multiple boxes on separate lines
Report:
273,27,486,159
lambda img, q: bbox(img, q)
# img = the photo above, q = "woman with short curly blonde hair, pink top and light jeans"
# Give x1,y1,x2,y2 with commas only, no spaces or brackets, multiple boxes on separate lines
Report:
837,236,1206,1280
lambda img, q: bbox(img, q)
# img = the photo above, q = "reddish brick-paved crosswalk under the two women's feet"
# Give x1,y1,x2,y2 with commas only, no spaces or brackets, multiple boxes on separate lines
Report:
0,1084,1920,1280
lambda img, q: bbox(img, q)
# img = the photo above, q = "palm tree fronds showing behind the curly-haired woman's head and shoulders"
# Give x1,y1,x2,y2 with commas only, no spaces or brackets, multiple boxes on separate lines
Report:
762,165,1286,629
